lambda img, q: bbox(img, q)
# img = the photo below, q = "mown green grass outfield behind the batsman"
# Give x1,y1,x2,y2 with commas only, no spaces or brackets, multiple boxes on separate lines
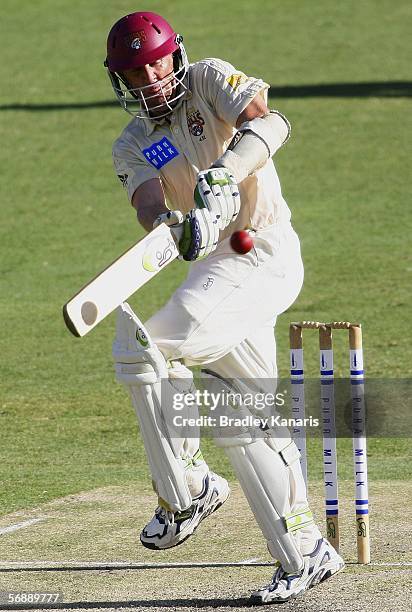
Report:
0,0,412,513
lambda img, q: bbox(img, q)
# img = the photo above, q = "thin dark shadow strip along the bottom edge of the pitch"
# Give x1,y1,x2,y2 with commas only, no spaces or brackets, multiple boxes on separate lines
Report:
0,597,255,610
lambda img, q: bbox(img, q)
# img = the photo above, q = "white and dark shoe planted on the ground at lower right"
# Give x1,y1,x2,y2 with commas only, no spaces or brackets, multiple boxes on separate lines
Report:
251,538,345,604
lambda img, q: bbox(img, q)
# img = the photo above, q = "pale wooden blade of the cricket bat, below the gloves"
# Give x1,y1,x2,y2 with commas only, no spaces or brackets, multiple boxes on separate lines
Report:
63,223,179,337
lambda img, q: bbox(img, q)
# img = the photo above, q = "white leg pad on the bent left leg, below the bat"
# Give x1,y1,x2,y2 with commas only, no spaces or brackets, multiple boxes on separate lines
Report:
113,303,198,511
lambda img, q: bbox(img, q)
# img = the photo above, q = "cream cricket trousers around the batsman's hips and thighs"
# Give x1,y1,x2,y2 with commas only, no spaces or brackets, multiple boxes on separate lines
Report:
146,221,303,378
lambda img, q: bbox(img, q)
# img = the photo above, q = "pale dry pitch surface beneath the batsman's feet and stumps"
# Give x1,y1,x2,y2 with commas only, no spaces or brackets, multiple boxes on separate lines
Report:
0,482,412,612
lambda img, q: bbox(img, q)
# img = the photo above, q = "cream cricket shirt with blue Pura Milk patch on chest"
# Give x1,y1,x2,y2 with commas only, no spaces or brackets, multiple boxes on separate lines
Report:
113,59,290,241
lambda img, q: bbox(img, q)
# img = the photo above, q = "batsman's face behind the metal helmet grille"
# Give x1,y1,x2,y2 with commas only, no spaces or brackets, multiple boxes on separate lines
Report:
122,54,174,109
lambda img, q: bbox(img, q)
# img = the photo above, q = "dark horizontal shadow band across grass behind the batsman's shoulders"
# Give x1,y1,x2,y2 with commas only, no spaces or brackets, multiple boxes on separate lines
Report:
0,81,412,112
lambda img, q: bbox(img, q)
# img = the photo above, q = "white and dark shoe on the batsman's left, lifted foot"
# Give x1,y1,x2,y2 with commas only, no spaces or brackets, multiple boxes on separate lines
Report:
140,472,230,550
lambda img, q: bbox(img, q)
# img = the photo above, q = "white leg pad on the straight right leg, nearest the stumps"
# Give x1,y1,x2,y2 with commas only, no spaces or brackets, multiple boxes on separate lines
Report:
202,370,306,572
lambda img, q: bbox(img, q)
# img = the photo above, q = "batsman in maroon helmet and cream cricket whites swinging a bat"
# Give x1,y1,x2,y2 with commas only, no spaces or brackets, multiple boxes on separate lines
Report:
105,12,344,603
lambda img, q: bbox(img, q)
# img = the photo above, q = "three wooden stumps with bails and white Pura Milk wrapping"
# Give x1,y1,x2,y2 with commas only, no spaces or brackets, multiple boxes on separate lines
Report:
289,321,370,564
